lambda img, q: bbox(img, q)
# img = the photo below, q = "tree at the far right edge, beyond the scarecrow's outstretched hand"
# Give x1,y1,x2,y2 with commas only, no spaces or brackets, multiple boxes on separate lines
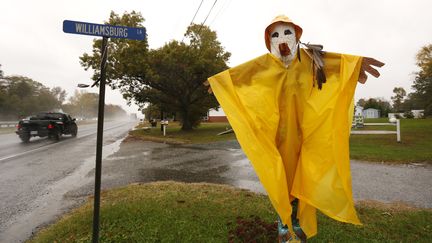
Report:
412,44,432,116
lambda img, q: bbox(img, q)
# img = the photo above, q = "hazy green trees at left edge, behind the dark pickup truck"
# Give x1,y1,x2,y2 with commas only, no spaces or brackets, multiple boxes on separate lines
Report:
0,76,66,120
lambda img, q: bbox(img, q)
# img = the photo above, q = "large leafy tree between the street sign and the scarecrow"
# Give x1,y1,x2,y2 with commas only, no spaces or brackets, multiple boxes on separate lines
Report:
80,12,230,130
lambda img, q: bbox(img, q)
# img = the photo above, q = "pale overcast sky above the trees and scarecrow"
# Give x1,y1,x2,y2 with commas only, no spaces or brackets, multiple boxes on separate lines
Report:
0,0,432,115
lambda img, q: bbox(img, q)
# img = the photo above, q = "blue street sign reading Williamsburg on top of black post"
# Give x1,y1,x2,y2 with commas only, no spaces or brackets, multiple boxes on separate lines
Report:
63,20,146,40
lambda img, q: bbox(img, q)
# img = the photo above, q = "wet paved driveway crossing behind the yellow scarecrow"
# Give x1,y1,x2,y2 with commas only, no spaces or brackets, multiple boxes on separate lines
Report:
69,139,432,208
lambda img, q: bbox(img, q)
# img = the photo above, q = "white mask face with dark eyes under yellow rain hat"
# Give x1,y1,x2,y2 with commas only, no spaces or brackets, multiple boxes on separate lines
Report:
270,23,297,67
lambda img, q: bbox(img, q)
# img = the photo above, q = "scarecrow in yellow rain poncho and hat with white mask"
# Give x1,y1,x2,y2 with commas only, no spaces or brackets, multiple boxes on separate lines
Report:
208,16,384,242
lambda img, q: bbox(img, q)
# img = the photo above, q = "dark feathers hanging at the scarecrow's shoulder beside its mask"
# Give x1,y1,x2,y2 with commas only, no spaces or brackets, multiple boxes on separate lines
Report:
301,43,327,90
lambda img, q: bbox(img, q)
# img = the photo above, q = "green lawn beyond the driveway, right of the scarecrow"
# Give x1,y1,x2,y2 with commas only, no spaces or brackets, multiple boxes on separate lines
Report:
350,118,432,164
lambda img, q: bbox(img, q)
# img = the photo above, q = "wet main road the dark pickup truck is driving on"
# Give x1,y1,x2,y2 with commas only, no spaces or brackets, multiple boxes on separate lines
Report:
0,121,136,243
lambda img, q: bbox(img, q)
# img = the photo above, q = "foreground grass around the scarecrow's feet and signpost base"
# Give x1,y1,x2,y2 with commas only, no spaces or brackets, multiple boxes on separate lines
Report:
28,182,432,243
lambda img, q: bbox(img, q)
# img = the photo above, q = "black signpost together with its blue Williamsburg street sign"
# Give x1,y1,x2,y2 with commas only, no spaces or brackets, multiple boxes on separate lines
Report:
63,20,146,243
